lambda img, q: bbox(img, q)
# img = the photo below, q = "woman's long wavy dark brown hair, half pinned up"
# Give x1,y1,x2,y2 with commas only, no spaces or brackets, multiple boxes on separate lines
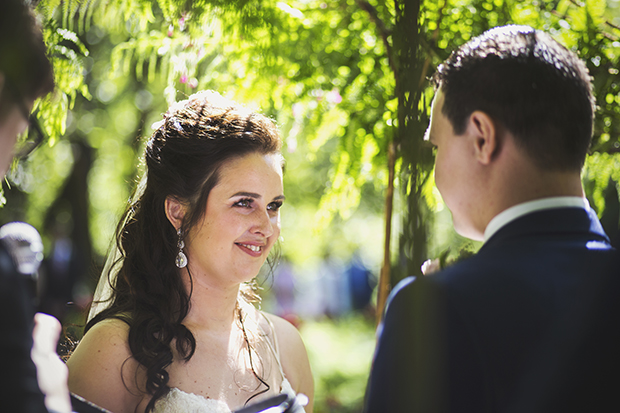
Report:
85,91,281,413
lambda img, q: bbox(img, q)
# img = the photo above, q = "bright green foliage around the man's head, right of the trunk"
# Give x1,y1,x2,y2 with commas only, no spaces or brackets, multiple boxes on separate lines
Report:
401,0,620,265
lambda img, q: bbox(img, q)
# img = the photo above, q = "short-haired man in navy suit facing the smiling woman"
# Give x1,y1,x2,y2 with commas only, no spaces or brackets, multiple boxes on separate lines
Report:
365,26,617,413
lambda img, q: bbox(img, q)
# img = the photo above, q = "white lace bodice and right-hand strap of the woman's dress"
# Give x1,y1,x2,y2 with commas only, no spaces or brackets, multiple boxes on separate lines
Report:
153,317,302,413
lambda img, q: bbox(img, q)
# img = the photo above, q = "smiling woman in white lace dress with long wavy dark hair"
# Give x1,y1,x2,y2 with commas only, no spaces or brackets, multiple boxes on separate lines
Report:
67,92,314,413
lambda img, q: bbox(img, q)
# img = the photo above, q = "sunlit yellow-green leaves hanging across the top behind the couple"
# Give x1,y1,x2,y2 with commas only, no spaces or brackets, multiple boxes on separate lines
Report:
17,0,620,253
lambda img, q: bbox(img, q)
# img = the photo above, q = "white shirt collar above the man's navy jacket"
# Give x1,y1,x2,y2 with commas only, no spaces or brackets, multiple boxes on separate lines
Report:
484,196,590,242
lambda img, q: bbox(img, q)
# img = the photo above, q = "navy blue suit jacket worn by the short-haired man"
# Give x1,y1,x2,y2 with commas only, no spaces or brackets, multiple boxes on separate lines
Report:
365,208,615,413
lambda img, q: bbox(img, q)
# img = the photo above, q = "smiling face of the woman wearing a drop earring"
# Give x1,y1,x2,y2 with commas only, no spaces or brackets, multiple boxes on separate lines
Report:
185,153,284,286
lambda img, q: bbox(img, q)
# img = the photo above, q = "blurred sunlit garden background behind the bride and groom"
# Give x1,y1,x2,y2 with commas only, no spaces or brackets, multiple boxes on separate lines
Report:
0,0,620,412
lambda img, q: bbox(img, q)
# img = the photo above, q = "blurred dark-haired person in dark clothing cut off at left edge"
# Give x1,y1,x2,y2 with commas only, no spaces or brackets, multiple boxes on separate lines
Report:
0,0,71,413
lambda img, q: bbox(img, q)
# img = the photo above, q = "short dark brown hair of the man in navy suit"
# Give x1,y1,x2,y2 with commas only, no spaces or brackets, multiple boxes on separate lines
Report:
434,26,595,171
